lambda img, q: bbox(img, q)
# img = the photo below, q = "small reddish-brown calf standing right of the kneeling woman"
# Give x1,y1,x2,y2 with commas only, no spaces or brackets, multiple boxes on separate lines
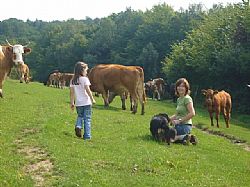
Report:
201,89,232,128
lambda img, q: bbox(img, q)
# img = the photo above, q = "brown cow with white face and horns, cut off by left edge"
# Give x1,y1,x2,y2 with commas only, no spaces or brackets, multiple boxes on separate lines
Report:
0,40,31,97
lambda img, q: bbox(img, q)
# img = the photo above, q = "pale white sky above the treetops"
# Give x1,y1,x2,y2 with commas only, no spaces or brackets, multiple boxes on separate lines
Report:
0,0,242,21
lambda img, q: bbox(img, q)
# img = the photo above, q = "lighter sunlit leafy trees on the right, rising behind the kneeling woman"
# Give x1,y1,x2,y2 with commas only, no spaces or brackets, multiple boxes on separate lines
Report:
164,2,250,113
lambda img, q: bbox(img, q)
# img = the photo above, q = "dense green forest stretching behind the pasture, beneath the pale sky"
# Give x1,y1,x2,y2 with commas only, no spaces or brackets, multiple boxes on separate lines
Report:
0,0,250,114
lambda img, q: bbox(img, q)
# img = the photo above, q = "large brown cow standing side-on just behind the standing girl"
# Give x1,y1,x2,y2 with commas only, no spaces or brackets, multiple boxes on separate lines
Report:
88,64,146,115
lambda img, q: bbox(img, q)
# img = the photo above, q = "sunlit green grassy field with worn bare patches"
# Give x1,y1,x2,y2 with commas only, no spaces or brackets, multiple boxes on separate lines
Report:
0,80,250,187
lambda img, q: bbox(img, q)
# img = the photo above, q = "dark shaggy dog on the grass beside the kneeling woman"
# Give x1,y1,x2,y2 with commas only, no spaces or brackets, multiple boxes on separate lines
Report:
150,113,177,145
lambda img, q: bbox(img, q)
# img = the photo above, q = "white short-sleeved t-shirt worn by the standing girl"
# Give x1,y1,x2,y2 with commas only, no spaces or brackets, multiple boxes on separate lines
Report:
70,77,92,106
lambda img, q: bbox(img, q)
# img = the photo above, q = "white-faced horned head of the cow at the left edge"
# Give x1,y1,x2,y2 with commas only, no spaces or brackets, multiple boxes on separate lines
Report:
6,40,31,65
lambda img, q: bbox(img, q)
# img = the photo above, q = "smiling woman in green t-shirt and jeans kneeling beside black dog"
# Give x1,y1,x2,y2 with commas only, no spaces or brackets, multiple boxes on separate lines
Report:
170,78,197,145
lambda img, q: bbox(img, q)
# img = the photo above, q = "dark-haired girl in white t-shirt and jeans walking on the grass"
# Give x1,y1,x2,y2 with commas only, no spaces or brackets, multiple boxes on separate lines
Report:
70,62,95,140
